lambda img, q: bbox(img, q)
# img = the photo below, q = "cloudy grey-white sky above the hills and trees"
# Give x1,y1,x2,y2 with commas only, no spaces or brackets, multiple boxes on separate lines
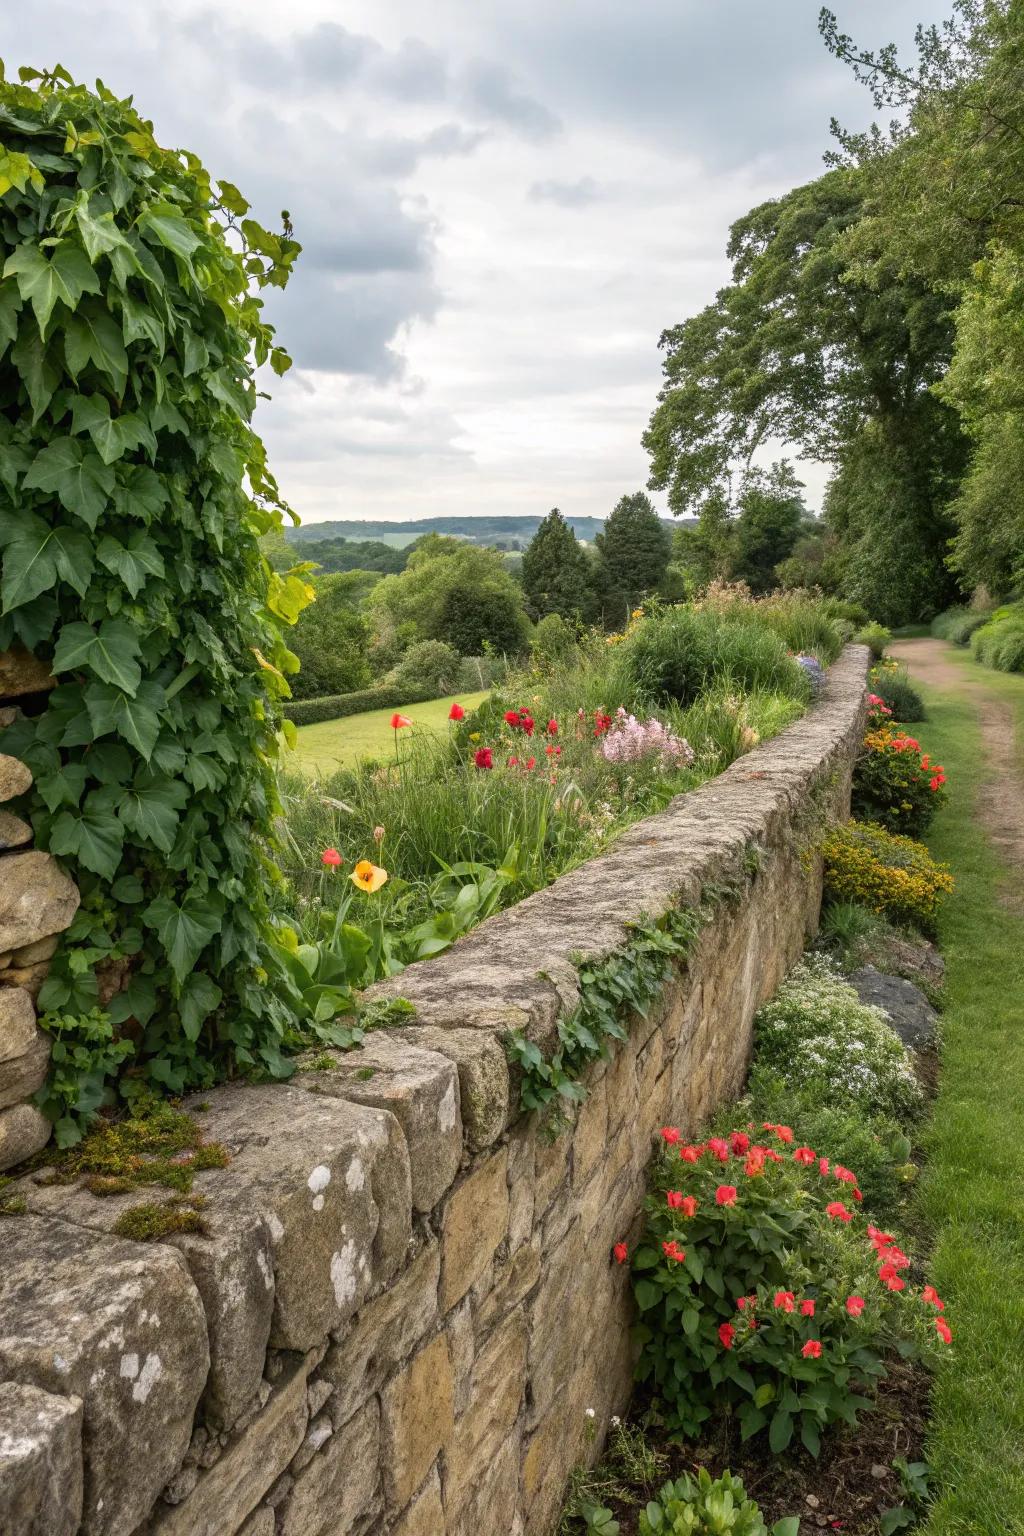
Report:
0,0,946,522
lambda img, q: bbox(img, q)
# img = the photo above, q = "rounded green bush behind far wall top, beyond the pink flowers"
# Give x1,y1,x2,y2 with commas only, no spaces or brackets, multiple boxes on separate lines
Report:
622,608,811,705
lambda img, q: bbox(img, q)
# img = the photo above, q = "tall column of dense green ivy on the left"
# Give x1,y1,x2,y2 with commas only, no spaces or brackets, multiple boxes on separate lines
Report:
0,66,312,1140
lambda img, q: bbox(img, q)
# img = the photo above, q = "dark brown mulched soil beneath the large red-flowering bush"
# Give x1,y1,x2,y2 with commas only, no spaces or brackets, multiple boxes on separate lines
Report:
603,1361,929,1536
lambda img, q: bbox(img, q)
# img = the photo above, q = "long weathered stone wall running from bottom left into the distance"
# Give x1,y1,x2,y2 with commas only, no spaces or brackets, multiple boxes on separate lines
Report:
0,648,867,1536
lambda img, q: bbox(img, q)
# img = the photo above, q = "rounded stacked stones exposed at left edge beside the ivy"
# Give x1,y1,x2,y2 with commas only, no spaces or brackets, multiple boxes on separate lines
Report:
0,651,78,1174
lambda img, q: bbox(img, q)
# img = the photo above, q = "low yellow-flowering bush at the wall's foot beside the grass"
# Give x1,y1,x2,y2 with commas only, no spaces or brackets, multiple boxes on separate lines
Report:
821,822,953,934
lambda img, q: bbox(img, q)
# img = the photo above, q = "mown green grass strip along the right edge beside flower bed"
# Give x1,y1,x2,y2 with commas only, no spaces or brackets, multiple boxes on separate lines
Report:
910,647,1024,1536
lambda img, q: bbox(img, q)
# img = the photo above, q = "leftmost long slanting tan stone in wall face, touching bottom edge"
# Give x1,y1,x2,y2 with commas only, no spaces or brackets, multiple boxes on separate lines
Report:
146,1358,310,1536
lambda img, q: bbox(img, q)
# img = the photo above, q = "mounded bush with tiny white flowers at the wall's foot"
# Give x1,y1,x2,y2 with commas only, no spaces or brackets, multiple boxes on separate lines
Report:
754,955,921,1120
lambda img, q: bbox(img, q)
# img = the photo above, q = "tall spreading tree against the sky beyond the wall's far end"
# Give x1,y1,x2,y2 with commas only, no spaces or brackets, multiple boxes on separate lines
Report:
645,166,966,619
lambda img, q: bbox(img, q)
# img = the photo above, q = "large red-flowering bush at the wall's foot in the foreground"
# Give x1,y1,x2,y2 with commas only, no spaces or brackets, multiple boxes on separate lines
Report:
629,1124,947,1455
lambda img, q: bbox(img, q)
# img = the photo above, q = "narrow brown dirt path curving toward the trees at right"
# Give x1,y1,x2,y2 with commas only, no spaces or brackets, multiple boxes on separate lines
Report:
890,639,1024,912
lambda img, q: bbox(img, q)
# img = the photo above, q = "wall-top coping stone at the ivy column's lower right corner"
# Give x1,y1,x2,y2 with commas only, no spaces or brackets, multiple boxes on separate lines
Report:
296,1032,462,1212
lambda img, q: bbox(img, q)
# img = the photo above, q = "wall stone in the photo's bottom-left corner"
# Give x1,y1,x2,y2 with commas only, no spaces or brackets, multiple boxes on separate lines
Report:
0,1381,81,1536
